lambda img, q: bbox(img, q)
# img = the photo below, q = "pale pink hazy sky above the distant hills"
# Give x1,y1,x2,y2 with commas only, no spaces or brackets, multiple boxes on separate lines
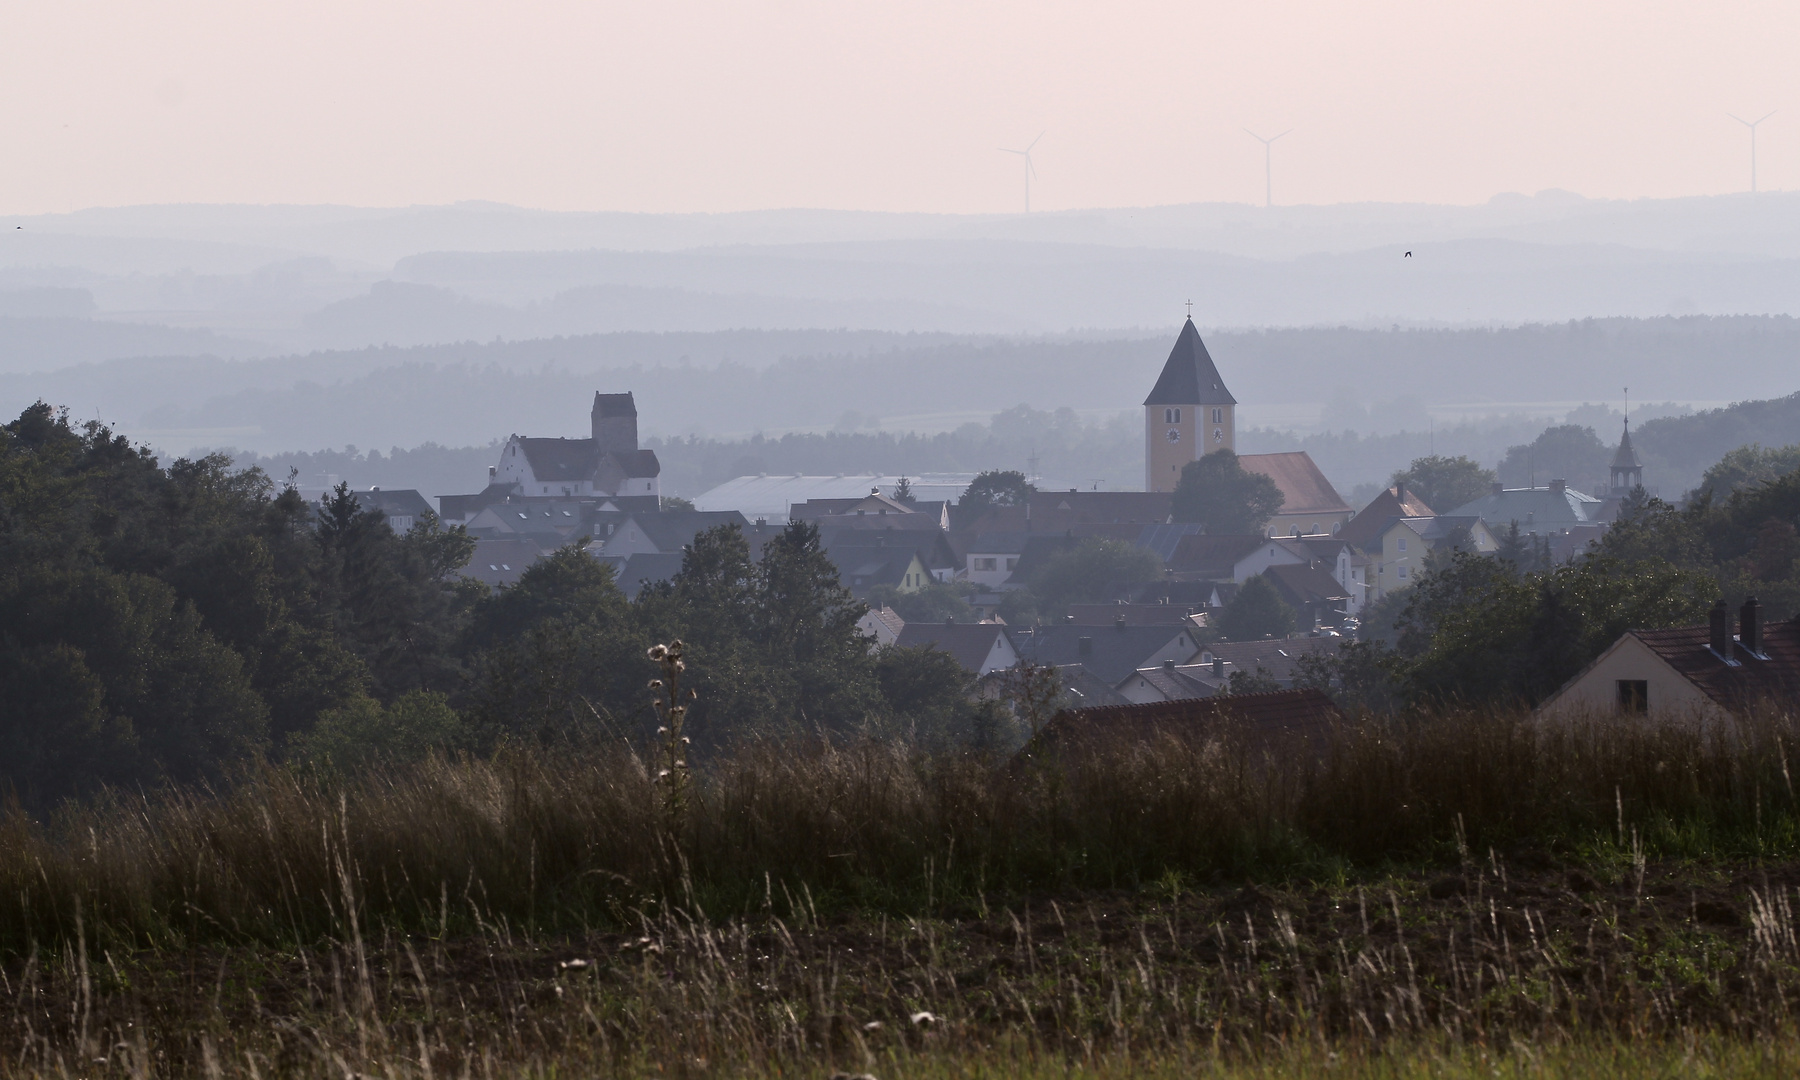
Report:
0,0,1800,212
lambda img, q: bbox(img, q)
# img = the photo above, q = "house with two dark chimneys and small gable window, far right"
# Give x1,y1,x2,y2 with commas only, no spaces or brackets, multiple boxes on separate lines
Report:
1537,598,1800,720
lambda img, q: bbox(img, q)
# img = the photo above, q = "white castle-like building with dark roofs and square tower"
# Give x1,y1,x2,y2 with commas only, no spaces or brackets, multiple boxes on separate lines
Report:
490,392,662,499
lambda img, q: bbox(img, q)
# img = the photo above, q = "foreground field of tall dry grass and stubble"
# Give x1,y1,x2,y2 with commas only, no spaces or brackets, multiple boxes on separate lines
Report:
0,715,1800,1080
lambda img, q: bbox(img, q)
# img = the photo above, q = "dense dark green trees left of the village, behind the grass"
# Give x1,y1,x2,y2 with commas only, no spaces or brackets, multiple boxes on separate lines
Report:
0,403,994,806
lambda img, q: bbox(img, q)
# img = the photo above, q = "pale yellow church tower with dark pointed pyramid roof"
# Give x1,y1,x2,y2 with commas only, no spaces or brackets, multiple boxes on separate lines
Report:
1143,317,1237,491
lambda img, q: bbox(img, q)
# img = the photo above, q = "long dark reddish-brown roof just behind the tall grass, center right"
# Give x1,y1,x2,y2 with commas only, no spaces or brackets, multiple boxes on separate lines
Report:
1019,689,1346,763
